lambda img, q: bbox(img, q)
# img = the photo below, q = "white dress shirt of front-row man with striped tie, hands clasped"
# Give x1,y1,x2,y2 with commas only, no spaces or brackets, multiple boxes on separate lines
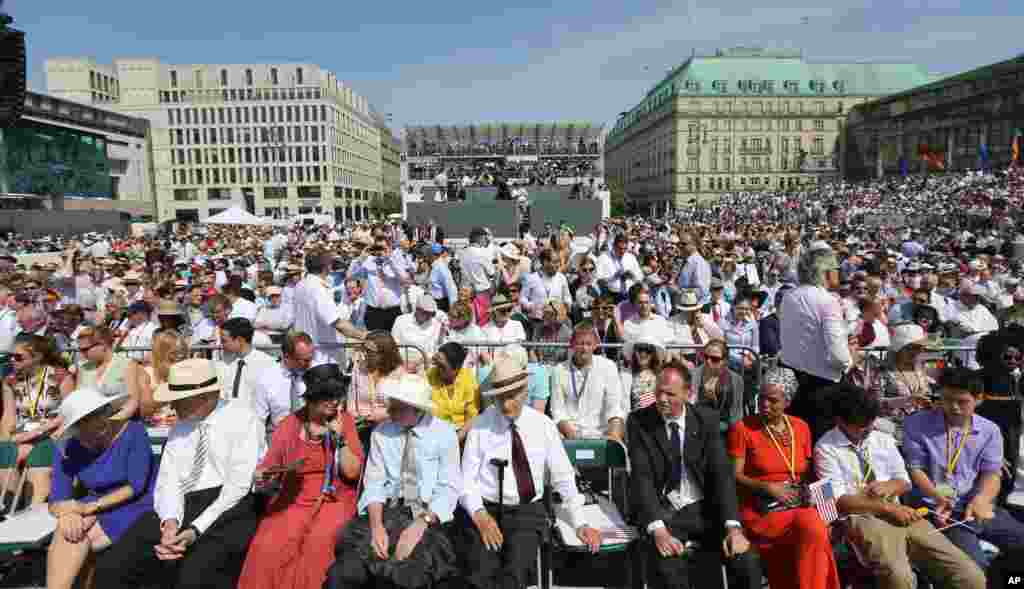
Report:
154,401,265,535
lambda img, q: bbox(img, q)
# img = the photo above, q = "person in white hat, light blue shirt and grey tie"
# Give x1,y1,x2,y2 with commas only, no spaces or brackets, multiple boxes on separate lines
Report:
325,374,462,589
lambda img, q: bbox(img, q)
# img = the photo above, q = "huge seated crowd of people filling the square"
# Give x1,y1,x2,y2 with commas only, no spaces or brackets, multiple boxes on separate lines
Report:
6,162,1024,589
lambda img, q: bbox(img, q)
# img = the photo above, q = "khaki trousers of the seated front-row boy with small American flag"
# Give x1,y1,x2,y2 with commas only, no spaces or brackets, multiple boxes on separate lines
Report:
847,515,985,589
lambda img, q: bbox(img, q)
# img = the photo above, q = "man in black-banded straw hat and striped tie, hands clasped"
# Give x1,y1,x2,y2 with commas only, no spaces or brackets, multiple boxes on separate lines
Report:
95,359,265,589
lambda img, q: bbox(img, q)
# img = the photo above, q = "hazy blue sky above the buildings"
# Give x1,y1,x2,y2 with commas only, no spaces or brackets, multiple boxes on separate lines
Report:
4,0,1024,130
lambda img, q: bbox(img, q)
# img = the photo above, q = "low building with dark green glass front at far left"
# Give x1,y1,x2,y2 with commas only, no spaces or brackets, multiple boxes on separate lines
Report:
0,85,156,217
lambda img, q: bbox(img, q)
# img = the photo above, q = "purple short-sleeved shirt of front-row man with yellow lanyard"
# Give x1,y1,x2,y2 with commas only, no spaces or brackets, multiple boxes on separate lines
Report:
903,409,1002,511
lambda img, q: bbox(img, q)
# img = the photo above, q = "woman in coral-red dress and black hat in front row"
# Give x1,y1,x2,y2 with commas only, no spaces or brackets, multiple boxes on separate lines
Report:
239,364,364,589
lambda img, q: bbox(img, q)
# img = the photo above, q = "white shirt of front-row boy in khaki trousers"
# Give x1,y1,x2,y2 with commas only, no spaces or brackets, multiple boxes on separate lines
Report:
814,427,910,500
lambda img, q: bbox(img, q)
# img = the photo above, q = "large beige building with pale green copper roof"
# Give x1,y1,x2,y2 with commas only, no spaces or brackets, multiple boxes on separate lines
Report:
604,48,932,211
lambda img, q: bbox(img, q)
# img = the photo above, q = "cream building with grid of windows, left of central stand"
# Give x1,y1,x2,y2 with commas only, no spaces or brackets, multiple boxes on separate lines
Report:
46,57,382,221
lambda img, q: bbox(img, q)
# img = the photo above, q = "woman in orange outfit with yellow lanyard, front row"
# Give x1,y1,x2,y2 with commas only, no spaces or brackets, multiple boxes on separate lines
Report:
728,369,840,589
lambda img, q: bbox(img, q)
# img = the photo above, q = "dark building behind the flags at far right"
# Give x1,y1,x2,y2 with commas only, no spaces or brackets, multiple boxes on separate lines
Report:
845,54,1024,178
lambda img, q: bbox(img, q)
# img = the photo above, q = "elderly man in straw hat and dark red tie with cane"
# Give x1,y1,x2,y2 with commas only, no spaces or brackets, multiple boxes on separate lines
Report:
457,357,601,589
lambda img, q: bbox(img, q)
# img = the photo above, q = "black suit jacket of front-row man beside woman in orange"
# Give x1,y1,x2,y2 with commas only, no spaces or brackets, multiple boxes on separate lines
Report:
626,405,739,534
